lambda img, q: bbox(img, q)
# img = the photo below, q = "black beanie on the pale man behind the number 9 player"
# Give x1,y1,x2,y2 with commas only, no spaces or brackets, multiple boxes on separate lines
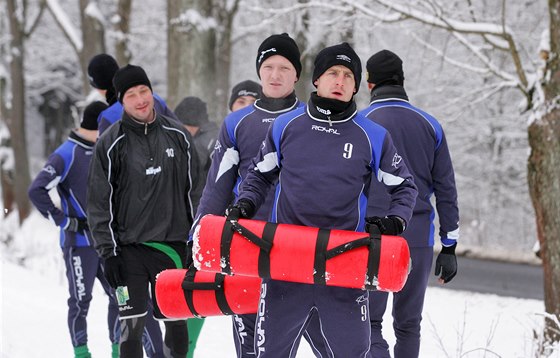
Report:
257,33,301,78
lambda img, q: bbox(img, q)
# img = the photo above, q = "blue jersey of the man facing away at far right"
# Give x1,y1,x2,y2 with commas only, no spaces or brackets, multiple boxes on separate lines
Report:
360,85,459,247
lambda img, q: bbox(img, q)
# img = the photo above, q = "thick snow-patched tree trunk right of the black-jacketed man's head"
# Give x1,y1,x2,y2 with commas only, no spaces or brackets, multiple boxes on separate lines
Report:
167,0,216,113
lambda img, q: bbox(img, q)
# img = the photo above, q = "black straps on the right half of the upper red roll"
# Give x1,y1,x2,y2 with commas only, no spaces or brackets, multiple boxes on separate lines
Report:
314,229,381,290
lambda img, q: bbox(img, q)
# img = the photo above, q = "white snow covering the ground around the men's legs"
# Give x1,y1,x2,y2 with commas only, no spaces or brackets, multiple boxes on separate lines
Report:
0,212,560,358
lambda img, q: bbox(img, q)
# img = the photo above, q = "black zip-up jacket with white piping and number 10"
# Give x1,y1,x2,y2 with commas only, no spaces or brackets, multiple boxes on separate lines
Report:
87,113,198,258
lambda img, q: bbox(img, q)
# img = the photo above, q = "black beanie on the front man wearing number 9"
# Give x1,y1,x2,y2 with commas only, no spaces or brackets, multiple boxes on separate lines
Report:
311,42,362,93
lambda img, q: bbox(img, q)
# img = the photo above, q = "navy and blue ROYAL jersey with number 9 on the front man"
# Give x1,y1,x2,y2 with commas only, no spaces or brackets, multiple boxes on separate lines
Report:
240,93,416,231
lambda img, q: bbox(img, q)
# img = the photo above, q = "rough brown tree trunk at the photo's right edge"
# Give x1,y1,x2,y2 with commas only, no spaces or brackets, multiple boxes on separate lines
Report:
528,0,560,342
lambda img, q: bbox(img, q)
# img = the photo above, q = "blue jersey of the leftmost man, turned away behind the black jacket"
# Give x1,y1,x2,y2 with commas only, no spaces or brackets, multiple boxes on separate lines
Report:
29,131,94,247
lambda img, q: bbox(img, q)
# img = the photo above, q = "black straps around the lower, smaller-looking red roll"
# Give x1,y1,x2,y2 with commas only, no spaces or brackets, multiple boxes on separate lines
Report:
182,267,235,317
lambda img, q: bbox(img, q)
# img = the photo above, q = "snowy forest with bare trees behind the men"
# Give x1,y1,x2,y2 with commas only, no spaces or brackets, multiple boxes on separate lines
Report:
4,0,560,346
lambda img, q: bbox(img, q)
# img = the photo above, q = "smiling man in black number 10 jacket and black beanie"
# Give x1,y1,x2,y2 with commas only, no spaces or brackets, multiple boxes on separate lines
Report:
87,65,198,358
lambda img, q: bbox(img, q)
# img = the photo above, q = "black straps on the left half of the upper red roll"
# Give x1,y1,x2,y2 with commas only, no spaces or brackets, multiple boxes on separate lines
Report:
220,220,278,278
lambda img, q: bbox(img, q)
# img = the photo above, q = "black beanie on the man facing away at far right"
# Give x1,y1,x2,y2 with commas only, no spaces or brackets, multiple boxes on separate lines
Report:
366,50,404,86
